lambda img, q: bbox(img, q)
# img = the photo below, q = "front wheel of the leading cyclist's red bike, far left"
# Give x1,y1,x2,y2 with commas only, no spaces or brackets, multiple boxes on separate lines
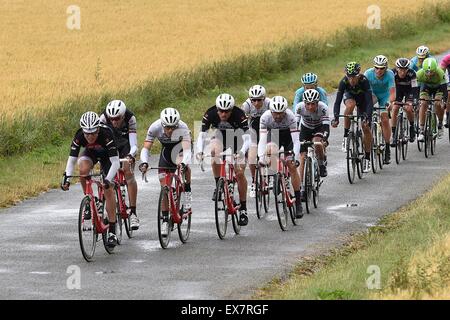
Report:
78,196,98,262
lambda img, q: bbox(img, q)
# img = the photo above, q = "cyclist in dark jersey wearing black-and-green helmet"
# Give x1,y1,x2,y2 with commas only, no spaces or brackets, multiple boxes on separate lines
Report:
331,62,373,171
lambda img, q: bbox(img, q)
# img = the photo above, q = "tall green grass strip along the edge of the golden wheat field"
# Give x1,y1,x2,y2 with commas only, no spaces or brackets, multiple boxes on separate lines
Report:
0,1,450,157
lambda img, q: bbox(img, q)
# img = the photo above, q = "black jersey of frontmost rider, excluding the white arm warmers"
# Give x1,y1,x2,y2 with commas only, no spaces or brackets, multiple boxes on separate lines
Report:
70,125,119,158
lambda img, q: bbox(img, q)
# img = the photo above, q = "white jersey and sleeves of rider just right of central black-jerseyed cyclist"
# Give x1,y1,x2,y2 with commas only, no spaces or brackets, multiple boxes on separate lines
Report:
258,109,300,157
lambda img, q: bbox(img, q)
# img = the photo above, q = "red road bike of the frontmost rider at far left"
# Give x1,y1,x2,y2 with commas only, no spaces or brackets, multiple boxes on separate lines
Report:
66,174,114,262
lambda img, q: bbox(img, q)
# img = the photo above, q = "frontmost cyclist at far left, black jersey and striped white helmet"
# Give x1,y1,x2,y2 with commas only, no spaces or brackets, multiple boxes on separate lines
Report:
61,111,120,247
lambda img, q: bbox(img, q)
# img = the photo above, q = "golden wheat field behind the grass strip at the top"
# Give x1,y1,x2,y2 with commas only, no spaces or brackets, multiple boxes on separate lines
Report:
0,0,436,115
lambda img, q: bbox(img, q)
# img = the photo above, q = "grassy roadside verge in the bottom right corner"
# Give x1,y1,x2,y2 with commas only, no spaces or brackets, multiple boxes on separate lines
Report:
254,175,450,300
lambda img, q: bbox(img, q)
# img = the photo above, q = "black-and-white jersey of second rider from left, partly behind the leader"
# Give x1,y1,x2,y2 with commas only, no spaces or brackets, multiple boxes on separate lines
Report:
100,109,137,158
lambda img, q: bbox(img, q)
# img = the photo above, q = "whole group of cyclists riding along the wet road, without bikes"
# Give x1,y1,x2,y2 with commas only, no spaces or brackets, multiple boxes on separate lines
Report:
61,46,450,247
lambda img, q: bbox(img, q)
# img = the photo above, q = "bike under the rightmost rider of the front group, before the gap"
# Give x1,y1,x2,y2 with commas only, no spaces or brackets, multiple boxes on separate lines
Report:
300,141,323,213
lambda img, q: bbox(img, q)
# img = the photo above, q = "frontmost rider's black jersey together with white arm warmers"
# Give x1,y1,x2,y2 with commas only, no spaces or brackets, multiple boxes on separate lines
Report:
66,125,120,181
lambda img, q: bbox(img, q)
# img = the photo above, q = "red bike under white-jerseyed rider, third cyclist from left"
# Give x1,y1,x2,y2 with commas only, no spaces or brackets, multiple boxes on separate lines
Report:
143,165,192,249
